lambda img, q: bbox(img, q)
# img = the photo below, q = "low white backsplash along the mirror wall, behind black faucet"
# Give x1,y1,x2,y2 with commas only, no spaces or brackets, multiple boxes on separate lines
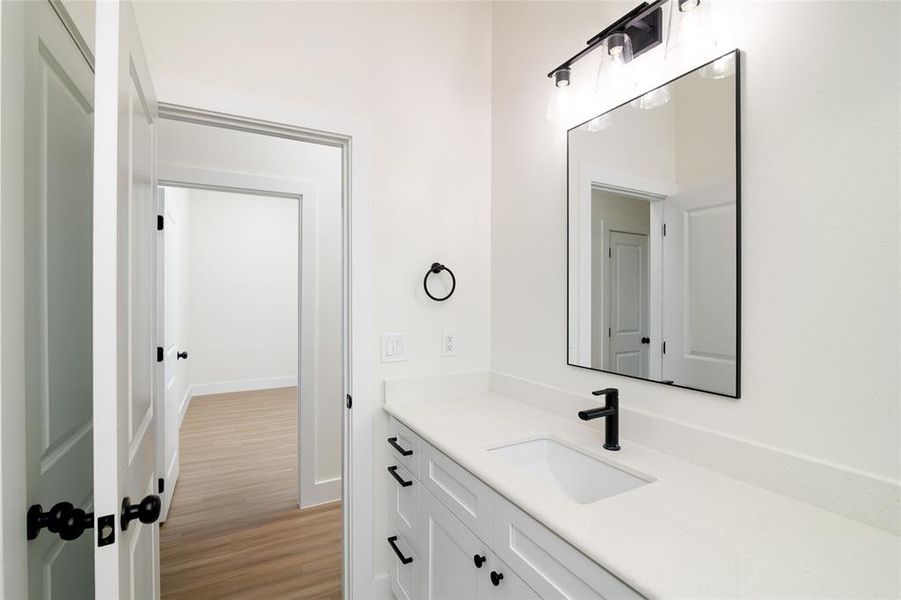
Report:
490,372,901,535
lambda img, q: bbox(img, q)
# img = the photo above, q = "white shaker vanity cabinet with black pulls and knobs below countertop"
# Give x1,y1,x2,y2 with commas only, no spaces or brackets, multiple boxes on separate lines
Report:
385,419,641,600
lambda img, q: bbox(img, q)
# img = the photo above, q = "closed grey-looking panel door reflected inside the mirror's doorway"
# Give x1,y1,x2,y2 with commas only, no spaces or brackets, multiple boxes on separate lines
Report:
607,231,650,377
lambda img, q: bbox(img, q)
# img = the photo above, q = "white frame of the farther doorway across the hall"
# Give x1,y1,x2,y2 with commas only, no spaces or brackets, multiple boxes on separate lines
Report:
156,164,341,513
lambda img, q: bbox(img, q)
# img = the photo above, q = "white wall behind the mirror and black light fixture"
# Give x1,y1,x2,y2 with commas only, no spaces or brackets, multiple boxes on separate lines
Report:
491,2,901,479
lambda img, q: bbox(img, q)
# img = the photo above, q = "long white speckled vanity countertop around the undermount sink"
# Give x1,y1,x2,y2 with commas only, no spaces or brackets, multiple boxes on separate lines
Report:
385,392,901,598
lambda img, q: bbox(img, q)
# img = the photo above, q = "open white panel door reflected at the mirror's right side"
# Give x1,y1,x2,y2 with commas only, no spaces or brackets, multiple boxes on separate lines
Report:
662,186,737,394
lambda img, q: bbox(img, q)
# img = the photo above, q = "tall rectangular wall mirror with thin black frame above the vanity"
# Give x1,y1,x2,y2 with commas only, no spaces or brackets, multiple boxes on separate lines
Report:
567,50,741,398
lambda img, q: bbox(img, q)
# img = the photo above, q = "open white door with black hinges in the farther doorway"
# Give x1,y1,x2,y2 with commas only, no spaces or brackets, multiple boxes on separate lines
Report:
156,187,188,522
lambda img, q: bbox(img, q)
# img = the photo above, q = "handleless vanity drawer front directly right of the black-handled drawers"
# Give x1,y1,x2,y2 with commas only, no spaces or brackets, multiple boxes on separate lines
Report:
420,443,495,539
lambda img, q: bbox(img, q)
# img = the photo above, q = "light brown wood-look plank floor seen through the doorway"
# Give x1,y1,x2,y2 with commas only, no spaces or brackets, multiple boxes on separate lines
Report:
160,387,341,600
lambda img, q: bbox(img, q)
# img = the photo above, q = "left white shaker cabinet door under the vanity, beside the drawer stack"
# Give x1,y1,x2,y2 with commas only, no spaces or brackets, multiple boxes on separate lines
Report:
421,490,492,600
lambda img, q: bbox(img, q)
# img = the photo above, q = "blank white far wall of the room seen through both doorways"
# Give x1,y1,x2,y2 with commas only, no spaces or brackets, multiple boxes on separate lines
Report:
183,189,299,396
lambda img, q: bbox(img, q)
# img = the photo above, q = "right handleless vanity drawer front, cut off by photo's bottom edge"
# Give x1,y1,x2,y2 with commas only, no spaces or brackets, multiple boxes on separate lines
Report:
492,495,642,599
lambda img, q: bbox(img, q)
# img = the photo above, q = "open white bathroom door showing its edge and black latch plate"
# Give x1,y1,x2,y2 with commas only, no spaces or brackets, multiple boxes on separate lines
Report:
94,2,160,598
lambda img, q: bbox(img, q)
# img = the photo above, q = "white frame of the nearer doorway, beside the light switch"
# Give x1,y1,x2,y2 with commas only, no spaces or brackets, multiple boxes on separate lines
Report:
159,102,374,598
